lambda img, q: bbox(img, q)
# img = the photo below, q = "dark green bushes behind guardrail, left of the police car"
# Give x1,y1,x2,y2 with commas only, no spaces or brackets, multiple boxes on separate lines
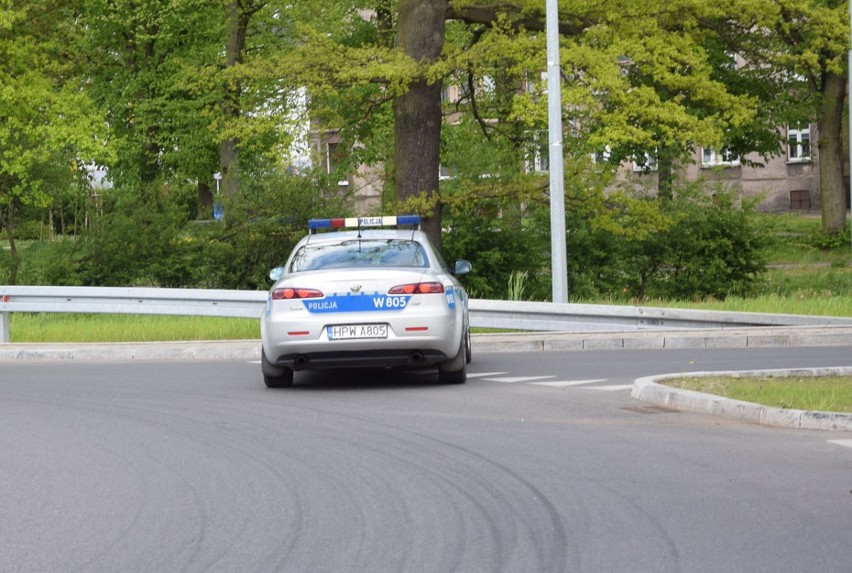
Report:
60,165,345,289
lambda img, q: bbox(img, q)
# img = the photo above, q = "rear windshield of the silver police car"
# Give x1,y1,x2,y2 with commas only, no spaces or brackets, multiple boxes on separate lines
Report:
290,239,429,273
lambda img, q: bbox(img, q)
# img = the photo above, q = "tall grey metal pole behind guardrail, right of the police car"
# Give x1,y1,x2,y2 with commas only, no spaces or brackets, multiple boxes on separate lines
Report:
545,0,568,302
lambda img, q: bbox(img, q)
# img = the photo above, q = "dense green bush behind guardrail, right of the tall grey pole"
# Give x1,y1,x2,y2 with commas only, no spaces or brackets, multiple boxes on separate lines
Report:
568,183,767,301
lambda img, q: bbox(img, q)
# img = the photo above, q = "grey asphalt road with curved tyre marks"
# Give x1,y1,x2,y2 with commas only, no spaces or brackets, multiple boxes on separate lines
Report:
0,347,852,573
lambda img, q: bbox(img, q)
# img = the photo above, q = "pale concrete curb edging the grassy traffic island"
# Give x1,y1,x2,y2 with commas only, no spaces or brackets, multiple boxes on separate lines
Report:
630,366,852,432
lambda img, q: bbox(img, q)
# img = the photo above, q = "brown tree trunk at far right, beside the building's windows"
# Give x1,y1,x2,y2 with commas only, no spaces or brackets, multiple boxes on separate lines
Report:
817,73,846,233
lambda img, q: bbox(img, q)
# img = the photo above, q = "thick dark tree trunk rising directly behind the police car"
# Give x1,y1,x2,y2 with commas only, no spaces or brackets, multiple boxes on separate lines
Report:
393,0,447,249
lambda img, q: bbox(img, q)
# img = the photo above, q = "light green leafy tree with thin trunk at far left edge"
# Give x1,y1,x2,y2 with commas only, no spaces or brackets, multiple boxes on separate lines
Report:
0,0,106,284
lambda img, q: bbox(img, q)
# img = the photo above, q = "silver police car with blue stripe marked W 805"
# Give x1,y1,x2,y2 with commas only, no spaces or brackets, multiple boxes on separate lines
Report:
260,215,471,388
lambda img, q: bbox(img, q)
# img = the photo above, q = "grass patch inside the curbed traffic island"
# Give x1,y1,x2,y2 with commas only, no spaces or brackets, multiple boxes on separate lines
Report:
663,376,852,412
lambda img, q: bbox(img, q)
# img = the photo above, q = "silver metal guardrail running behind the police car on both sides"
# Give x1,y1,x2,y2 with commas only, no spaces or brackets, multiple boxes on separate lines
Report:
5,286,852,343
